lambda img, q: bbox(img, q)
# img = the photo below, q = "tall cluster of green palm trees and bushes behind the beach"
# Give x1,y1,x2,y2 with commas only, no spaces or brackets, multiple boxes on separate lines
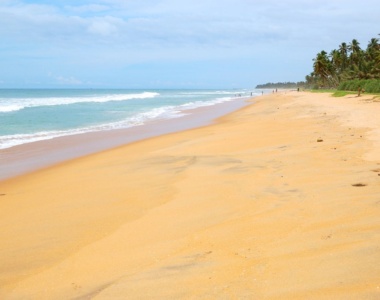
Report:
306,38,380,93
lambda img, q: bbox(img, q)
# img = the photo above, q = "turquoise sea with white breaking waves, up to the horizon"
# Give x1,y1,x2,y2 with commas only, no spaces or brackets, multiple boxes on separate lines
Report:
0,89,261,149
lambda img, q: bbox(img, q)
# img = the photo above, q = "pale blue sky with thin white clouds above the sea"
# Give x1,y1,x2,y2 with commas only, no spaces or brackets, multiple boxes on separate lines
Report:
0,0,380,89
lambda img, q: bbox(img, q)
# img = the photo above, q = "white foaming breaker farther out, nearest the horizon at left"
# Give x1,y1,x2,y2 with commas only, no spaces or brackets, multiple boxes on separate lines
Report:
0,92,160,112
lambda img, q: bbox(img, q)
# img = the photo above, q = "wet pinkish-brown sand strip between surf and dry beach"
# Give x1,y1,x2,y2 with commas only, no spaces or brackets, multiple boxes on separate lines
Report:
0,97,252,182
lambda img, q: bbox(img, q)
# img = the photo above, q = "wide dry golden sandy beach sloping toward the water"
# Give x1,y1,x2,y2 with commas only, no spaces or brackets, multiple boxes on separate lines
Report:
0,91,380,299
